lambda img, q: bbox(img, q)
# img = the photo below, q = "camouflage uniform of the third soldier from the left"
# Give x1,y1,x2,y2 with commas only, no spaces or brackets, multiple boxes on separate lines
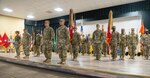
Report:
34,34,41,56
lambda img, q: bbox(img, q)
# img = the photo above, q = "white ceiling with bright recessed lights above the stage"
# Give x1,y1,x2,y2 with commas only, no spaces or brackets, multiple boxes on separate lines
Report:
0,0,143,20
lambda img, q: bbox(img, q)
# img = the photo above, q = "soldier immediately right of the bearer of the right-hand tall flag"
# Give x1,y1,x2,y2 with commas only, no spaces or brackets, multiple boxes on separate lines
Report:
119,29,127,60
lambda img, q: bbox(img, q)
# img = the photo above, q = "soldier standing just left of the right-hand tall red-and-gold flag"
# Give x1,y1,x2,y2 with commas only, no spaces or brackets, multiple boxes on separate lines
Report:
92,24,104,60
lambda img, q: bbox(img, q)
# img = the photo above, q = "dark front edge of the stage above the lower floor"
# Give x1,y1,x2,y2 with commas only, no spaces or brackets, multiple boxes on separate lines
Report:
0,56,150,78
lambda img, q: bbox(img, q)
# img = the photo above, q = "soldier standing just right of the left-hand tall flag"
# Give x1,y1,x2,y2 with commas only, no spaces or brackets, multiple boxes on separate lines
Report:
72,27,81,61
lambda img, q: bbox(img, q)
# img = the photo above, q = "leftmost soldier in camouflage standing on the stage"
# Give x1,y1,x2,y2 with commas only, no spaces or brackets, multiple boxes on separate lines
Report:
15,31,21,58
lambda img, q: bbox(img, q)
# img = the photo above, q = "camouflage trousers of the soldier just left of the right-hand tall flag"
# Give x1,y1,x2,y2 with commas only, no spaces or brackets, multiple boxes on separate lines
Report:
94,43,102,60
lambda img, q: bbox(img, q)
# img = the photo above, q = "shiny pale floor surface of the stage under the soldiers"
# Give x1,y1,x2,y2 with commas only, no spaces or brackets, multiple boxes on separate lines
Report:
0,53,150,76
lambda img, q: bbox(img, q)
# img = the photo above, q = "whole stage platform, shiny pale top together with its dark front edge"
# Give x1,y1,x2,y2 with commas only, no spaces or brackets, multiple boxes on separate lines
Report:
0,53,150,78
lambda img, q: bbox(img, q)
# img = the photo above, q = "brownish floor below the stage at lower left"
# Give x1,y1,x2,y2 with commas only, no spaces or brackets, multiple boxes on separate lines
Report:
0,61,87,78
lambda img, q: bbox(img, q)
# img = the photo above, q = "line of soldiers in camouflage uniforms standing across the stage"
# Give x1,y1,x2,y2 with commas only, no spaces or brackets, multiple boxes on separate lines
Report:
15,19,147,64
